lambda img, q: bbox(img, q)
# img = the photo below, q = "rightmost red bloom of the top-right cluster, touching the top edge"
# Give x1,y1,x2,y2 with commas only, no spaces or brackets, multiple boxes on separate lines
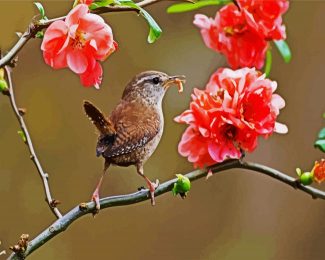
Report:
237,0,289,40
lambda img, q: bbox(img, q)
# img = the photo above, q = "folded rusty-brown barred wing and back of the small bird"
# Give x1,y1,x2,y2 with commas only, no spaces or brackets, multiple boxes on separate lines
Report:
103,101,160,158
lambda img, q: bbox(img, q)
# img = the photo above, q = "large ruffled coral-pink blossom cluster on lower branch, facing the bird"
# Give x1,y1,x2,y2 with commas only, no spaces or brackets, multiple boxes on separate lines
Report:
175,68,288,167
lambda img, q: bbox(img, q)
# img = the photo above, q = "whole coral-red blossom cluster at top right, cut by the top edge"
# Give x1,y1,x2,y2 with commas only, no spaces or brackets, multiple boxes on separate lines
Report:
194,0,289,69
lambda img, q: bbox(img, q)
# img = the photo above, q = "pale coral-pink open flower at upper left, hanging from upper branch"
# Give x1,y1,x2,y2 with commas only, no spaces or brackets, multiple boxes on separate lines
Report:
41,4,117,88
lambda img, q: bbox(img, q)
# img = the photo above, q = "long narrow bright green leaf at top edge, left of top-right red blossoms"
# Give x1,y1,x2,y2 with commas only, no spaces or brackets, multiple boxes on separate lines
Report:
167,0,231,14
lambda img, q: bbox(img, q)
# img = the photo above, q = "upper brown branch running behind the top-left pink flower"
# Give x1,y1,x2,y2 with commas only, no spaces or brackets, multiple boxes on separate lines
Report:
0,0,164,68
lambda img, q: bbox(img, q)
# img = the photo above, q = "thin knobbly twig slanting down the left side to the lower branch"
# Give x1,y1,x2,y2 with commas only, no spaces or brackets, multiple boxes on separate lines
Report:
5,66,62,218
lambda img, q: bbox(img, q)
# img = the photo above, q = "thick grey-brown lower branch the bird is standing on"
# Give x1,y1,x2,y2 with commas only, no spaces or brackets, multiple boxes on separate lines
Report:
8,160,325,259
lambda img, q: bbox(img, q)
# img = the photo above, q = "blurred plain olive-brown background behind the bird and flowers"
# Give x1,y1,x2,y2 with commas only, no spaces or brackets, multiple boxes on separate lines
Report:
0,0,325,260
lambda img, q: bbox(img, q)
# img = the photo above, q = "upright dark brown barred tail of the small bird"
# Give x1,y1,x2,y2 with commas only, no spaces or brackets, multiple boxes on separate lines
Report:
84,101,116,136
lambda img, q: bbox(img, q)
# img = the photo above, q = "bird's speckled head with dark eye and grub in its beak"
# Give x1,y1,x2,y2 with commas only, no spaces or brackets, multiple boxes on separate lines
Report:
122,71,185,105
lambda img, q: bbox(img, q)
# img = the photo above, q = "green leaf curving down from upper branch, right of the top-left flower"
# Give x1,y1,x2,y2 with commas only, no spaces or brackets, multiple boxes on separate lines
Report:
119,0,162,43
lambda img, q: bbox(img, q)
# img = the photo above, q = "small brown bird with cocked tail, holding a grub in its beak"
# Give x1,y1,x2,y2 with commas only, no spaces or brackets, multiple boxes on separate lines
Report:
84,71,185,212
